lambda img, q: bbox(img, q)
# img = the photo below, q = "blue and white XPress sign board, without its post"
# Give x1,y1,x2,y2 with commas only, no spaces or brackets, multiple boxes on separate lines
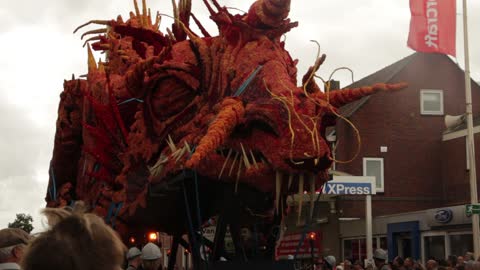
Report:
324,176,376,195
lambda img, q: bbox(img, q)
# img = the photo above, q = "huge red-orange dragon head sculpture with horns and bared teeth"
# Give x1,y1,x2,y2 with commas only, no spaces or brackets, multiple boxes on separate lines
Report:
46,0,405,264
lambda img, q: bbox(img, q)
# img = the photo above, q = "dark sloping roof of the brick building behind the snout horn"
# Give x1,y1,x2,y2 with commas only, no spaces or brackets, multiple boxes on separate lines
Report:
340,53,418,117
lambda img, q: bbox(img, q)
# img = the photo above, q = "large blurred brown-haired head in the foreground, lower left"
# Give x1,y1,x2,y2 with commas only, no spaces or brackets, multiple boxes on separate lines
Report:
21,203,125,270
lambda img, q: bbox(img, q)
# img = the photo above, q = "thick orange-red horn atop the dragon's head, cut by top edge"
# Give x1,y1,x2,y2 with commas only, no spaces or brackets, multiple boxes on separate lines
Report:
247,0,290,27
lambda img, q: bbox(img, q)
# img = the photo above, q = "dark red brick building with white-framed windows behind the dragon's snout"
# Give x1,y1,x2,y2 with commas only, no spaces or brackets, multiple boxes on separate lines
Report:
329,53,480,259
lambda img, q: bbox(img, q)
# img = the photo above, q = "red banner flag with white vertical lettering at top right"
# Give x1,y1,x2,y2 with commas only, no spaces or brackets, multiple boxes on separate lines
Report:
408,0,457,56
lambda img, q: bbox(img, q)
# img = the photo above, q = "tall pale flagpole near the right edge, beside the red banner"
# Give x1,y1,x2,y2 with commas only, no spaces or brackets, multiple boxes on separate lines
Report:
463,0,480,260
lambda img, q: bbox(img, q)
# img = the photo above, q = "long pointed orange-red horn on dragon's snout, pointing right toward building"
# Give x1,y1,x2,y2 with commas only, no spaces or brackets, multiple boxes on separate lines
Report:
314,83,408,108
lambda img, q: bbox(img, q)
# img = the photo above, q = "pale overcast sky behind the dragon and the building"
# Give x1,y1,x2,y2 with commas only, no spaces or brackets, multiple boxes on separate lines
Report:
0,0,480,231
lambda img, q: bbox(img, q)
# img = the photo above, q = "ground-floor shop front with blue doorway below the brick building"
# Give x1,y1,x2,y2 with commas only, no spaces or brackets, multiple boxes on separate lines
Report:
340,205,473,261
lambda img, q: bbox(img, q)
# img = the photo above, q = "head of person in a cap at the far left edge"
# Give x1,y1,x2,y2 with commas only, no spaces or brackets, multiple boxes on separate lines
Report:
0,228,30,263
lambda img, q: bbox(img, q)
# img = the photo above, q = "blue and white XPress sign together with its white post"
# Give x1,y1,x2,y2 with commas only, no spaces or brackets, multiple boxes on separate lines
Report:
325,175,377,260
